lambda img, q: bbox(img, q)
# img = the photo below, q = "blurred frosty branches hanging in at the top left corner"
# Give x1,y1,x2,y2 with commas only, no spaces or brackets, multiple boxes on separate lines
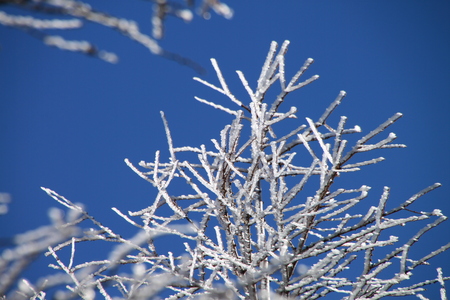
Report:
0,0,233,73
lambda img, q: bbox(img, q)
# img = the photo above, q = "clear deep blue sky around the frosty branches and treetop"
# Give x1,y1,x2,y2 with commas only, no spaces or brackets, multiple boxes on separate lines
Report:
0,0,450,299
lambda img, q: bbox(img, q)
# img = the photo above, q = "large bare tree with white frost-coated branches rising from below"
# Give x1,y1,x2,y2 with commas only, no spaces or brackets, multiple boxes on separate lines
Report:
0,41,450,300
